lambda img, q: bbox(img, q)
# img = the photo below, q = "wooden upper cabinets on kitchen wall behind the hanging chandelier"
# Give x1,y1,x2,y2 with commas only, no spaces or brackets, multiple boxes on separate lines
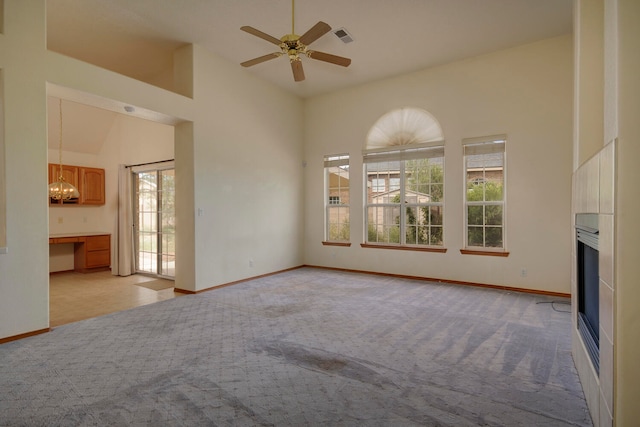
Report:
49,163,105,206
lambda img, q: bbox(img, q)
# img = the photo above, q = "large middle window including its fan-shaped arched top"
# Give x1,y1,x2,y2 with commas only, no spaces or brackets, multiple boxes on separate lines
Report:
363,108,444,249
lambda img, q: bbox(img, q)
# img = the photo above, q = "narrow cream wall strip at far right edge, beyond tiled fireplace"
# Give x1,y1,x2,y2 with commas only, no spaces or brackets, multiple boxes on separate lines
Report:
614,0,640,426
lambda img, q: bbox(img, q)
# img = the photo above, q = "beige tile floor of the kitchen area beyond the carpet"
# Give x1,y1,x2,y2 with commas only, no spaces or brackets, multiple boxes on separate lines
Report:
49,271,184,328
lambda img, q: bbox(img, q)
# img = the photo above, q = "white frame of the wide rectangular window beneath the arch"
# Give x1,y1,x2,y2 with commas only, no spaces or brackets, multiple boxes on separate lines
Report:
363,145,445,248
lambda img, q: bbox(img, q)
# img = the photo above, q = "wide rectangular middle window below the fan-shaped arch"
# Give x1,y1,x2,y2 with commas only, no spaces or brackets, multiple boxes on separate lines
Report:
364,146,444,246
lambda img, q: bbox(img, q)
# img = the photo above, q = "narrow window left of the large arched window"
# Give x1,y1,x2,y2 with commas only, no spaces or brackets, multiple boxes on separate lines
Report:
324,154,350,242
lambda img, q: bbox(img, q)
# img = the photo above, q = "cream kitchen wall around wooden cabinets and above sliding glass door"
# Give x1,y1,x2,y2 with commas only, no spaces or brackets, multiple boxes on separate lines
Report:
49,114,174,272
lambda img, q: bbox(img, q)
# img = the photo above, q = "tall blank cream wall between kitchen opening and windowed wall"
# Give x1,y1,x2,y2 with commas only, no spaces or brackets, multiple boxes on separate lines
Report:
191,47,304,290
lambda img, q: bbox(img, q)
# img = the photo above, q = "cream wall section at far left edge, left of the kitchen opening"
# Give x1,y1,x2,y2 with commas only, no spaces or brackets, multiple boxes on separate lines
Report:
0,1,49,337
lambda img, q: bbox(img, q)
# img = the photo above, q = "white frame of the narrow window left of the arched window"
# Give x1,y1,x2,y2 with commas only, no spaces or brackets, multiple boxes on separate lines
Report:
324,154,351,243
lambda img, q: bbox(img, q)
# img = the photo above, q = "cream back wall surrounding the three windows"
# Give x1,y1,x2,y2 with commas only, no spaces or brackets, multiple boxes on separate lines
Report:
304,36,573,294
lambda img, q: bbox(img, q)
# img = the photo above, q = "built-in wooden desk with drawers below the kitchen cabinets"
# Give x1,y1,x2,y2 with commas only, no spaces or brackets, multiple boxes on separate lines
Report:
49,233,111,273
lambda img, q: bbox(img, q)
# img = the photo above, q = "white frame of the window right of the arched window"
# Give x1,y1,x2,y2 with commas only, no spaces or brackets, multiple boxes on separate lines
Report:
462,135,507,252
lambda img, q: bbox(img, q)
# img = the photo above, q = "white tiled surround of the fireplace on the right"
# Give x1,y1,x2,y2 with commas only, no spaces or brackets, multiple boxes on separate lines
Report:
571,141,616,426
